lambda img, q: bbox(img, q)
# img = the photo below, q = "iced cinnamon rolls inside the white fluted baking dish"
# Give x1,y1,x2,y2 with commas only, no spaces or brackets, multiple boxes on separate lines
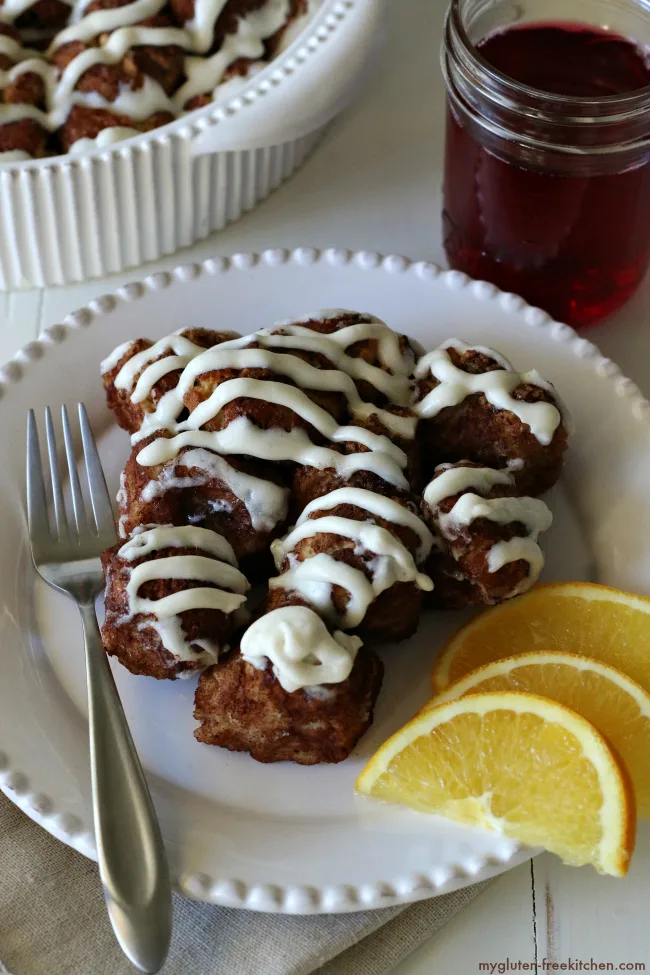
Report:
0,0,312,162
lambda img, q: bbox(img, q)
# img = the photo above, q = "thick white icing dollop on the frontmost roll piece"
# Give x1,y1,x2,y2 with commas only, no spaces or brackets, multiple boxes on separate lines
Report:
241,606,362,696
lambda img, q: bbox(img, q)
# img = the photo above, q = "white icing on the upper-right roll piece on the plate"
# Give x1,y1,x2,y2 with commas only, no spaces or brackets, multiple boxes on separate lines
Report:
414,339,562,446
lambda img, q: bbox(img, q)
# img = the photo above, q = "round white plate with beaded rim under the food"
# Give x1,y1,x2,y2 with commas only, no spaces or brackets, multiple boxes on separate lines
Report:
0,248,650,913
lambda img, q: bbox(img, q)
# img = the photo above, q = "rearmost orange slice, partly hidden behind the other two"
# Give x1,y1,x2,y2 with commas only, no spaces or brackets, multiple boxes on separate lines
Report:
431,582,650,692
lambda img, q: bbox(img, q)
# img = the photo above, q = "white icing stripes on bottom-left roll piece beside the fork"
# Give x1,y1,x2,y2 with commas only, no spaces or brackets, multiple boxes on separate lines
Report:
118,525,249,664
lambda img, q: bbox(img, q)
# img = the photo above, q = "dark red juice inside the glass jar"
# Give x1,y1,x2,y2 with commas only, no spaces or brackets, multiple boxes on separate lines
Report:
443,23,650,325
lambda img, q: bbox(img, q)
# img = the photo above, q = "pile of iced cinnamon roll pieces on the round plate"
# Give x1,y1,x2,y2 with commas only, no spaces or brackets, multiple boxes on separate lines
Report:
102,309,569,764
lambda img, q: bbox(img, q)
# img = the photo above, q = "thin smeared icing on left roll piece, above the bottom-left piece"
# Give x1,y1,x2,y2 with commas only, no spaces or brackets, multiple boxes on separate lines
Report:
141,448,289,531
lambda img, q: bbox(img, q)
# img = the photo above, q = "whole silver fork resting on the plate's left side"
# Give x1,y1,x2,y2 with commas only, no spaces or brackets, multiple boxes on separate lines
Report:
27,403,171,973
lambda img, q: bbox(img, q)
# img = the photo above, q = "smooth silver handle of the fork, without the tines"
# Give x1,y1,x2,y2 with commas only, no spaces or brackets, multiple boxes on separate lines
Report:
80,603,172,973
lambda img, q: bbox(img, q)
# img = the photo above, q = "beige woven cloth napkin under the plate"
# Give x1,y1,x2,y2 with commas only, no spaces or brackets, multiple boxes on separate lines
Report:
0,793,486,975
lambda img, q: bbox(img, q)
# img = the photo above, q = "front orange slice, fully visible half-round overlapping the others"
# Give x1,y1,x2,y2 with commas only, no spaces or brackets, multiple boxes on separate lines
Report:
357,691,636,877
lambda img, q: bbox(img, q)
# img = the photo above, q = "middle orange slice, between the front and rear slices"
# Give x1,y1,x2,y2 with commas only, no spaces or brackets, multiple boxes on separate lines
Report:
423,651,650,819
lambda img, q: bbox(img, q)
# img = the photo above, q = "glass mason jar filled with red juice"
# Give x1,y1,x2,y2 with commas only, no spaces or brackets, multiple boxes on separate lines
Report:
442,0,650,326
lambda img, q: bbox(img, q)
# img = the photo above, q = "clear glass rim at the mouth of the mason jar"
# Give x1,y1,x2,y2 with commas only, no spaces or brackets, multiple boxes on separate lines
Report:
447,0,650,118
